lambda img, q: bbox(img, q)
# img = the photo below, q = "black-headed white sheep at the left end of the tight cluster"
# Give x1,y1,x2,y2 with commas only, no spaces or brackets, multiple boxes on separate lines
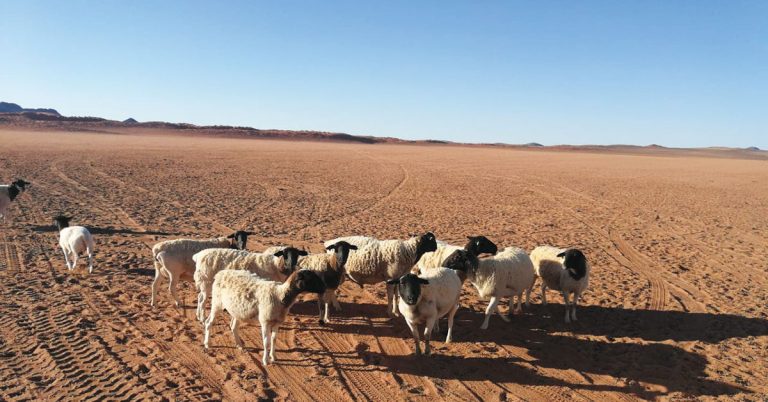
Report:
150,231,249,307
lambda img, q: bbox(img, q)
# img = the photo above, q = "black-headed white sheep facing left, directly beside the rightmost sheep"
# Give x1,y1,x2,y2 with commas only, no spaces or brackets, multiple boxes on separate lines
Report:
446,247,536,329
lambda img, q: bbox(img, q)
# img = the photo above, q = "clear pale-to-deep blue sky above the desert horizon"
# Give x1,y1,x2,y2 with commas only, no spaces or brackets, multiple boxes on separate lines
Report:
0,0,768,149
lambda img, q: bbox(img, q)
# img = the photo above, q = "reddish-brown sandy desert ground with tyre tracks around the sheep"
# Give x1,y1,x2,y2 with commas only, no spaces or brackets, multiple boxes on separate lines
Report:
0,130,768,401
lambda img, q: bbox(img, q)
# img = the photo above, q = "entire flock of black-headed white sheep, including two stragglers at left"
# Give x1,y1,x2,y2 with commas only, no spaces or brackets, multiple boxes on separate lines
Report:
0,180,590,365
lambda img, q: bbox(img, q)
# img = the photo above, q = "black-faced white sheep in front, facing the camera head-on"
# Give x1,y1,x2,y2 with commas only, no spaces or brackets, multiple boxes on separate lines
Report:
387,268,461,356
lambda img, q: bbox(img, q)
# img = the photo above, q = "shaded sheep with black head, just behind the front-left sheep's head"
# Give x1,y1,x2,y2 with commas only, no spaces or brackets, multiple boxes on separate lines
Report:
299,240,358,325
